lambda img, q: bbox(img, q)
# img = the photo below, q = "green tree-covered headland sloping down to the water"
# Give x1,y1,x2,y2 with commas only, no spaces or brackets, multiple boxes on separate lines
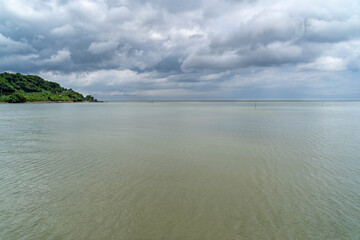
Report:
0,72,97,103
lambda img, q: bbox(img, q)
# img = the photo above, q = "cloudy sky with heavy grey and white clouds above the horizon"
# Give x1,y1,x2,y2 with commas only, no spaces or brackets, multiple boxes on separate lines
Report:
0,0,360,100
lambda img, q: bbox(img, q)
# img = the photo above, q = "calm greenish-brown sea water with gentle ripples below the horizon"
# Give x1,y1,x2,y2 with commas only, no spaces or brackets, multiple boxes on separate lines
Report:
0,102,360,240
